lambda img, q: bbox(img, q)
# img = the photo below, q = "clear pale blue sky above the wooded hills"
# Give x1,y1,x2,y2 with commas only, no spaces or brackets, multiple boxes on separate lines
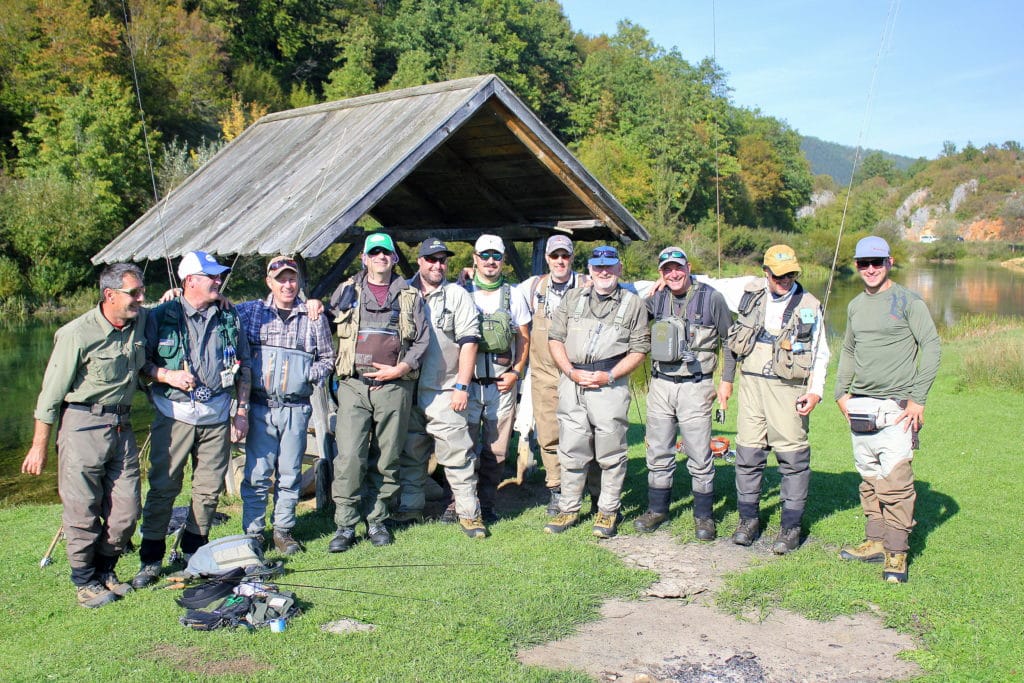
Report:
561,0,1024,159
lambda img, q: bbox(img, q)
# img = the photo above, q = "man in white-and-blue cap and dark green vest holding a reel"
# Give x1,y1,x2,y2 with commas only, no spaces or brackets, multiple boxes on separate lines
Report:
132,251,251,588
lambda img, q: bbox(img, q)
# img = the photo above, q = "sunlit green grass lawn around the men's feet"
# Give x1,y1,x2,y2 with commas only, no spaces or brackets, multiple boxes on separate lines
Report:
0,325,1024,681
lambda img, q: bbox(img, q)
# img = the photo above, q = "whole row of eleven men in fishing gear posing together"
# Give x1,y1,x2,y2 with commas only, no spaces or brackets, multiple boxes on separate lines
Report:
23,232,939,607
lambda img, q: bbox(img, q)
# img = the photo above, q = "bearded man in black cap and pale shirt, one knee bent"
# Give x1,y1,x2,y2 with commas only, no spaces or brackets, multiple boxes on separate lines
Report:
392,238,487,539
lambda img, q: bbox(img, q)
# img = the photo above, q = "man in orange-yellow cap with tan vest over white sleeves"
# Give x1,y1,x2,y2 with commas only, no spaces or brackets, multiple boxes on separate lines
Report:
728,245,829,555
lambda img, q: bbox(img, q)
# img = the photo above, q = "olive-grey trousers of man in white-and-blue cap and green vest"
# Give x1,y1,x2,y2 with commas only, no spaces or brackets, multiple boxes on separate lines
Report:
142,411,231,542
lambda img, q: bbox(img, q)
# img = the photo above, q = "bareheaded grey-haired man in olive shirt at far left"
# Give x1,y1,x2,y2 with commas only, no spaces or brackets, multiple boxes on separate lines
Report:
22,263,145,607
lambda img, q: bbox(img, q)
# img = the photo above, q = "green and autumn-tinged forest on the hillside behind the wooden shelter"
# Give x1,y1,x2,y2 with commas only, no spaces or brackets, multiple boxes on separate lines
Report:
0,0,1020,308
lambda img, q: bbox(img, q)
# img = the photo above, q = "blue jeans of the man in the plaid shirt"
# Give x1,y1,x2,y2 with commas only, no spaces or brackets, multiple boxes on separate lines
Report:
240,403,312,533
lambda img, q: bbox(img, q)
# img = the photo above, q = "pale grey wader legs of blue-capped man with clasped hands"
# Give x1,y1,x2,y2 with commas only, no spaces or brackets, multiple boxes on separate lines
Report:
558,376,630,514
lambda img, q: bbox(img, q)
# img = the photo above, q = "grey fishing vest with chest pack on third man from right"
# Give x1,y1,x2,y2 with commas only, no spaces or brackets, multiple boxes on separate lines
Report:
650,279,719,377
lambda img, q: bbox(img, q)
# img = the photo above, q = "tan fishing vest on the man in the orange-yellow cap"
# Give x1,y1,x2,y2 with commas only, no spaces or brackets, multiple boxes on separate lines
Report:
728,282,821,384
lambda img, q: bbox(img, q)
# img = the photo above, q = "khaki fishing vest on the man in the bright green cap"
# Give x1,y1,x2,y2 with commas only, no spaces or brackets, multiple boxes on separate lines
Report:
335,276,420,380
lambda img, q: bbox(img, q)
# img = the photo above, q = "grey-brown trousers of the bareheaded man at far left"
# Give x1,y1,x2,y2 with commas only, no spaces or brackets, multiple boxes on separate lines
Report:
57,409,141,586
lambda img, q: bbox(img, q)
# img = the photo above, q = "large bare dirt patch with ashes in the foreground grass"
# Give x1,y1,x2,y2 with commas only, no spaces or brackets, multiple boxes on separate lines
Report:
519,531,922,683
